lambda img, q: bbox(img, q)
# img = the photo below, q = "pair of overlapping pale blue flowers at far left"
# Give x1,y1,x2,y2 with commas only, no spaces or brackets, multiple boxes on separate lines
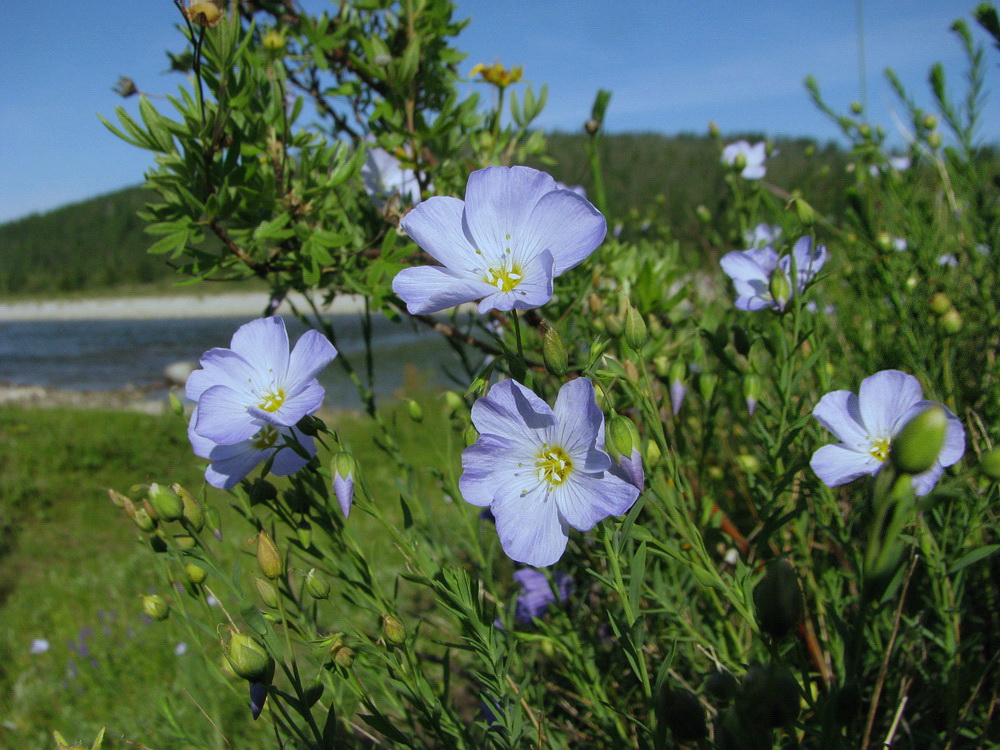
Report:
187,317,337,489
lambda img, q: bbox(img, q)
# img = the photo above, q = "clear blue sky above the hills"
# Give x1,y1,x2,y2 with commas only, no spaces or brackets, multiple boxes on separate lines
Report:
0,0,988,221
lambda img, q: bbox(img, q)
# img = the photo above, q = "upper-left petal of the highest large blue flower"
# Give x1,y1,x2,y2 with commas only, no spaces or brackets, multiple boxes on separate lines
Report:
397,195,481,274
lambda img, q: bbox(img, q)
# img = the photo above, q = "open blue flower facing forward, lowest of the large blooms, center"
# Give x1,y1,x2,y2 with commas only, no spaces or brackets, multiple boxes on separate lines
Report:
459,378,639,567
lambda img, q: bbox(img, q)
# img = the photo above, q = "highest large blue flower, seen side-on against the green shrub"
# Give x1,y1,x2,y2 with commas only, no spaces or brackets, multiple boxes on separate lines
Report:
392,167,607,314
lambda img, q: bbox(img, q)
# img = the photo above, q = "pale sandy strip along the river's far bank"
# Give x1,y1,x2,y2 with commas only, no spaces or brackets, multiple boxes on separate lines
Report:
0,292,364,321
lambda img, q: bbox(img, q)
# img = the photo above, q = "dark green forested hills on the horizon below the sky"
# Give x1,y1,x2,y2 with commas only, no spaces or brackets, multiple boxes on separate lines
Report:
0,133,849,295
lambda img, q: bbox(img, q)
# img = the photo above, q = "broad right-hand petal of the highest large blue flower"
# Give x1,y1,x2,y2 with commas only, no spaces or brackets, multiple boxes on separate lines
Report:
514,190,608,276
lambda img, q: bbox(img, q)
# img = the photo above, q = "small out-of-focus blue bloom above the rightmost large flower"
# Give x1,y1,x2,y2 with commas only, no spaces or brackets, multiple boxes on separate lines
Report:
719,237,827,310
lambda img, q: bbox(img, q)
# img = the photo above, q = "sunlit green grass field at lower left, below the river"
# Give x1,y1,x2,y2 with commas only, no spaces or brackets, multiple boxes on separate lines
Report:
0,402,464,748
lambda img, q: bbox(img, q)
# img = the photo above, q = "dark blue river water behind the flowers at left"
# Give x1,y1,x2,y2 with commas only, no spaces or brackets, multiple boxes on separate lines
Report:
0,315,474,408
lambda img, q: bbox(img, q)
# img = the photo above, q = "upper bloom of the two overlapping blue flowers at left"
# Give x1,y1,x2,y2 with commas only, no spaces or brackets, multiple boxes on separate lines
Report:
187,317,337,446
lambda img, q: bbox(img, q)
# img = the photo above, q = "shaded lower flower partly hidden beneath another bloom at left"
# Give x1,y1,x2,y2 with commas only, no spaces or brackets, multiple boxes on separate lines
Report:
188,407,316,490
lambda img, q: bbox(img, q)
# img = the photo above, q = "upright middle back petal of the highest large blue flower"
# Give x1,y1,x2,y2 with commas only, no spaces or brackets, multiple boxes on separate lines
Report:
465,167,556,257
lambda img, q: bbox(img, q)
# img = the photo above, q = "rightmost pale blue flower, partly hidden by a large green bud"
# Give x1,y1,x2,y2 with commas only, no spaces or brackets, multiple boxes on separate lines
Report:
809,370,965,495
